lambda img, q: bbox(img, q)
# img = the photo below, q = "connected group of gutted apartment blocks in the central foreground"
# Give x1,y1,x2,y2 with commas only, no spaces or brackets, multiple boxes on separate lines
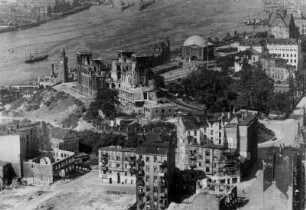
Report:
99,111,258,209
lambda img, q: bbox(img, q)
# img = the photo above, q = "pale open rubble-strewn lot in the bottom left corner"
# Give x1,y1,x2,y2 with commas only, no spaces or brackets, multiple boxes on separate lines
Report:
0,170,136,210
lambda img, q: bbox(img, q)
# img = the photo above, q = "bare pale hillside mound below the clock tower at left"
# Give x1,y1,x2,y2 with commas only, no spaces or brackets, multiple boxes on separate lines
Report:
2,88,86,128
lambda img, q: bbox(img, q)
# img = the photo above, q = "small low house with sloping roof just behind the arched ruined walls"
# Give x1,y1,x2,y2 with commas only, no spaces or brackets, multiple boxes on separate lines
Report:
51,128,79,153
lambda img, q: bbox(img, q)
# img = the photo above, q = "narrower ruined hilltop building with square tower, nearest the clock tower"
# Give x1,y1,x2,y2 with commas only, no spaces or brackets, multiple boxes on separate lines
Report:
77,52,110,99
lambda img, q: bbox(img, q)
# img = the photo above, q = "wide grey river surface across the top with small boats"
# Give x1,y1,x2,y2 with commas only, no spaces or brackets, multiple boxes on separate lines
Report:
0,0,262,85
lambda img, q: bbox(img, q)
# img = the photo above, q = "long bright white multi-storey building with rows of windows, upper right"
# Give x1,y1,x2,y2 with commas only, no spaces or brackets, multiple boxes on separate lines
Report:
238,38,302,69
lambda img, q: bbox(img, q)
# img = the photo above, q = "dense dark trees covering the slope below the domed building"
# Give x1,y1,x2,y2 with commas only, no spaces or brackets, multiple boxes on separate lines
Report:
170,64,293,114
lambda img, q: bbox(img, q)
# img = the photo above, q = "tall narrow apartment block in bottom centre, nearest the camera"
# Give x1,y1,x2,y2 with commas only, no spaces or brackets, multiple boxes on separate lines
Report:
136,142,175,210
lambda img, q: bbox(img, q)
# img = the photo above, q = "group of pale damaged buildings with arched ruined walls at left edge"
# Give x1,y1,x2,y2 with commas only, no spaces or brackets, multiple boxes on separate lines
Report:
0,122,81,184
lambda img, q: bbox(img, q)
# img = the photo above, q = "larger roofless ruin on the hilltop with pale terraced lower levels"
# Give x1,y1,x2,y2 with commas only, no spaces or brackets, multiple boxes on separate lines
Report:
109,40,170,114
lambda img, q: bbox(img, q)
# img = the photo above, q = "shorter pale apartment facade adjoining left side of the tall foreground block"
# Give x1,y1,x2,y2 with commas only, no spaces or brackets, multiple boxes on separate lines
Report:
99,146,137,185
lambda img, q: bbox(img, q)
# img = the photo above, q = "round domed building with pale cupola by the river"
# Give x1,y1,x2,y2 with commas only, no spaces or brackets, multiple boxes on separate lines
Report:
182,35,214,61
